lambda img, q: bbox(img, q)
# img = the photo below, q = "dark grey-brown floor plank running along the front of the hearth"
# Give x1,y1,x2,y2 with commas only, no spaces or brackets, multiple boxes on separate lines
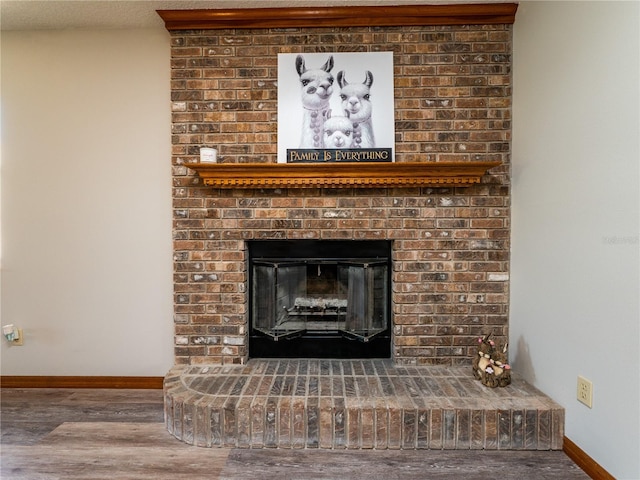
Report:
220,450,589,480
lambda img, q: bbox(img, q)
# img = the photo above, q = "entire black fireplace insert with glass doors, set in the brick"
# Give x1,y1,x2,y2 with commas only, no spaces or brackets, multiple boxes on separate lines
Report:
248,240,391,358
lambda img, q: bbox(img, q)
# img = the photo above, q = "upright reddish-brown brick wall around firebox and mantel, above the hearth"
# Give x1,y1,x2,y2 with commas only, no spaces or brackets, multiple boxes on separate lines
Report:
171,25,511,364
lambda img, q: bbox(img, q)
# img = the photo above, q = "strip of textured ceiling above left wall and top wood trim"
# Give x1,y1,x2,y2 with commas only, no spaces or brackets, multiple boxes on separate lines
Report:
0,0,507,30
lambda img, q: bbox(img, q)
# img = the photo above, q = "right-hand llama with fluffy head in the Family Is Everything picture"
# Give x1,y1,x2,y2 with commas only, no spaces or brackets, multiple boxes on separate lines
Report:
338,70,376,148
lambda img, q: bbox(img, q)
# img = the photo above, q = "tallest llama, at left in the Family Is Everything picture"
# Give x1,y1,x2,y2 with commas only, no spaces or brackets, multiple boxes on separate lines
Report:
296,55,333,148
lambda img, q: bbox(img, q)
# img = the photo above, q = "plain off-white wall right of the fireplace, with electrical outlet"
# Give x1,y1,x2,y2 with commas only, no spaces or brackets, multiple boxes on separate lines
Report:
510,2,640,479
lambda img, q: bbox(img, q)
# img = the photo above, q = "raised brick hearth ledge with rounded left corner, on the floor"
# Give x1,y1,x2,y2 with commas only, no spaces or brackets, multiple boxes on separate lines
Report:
164,359,564,450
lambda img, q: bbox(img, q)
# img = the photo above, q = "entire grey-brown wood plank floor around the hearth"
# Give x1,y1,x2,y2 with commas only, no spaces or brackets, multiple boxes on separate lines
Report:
0,389,589,480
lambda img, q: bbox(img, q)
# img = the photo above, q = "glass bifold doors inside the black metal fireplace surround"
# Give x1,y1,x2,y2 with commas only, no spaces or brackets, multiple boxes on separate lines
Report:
252,259,389,342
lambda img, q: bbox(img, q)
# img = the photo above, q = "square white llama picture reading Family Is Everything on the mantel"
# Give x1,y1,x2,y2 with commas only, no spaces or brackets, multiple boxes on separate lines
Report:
278,52,395,163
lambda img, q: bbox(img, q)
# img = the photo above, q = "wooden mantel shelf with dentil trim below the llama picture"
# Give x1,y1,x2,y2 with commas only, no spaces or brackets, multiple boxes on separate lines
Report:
185,162,500,188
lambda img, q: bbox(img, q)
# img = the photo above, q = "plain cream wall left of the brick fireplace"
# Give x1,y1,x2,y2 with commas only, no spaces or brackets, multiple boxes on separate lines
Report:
0,29,173,376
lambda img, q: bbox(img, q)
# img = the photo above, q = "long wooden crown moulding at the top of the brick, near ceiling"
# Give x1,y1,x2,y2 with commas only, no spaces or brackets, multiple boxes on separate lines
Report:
157,3,518,31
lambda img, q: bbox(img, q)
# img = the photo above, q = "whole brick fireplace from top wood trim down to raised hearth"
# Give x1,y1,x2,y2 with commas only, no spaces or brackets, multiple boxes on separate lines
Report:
159,4,564,449
